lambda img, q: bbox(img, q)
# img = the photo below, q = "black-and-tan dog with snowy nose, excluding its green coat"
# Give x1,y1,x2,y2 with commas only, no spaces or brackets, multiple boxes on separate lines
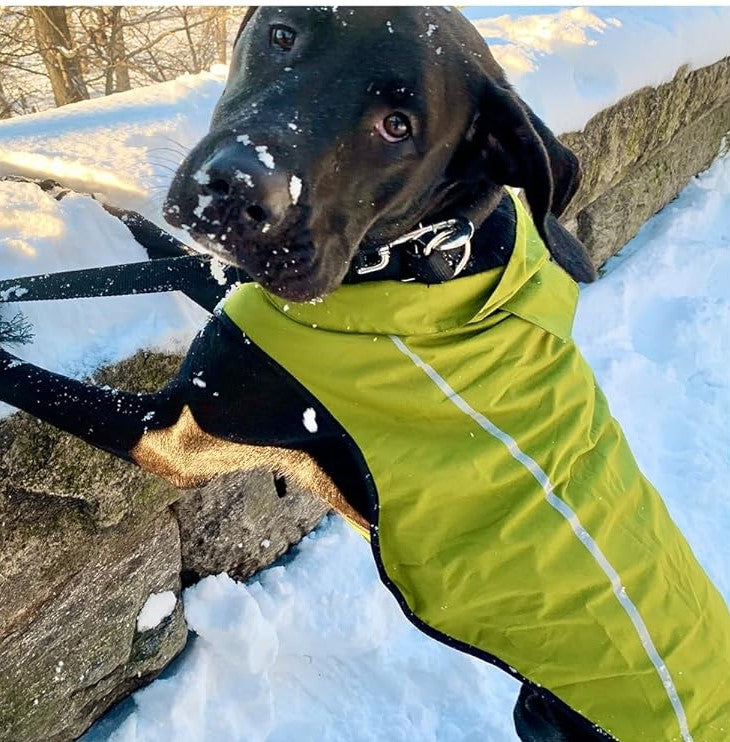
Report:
0,8,605,740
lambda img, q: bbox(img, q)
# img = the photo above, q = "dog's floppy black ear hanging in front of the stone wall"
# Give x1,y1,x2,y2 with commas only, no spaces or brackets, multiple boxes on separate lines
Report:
468,78,596,283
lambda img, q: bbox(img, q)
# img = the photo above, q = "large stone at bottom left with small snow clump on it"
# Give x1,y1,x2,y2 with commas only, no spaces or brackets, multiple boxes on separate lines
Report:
0,492,187,740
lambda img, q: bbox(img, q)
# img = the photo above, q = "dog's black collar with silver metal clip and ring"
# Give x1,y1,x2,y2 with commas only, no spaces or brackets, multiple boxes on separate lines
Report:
344,194,517,284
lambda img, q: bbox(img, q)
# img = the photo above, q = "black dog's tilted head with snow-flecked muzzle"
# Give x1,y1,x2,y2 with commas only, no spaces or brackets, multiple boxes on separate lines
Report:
165,7,590,301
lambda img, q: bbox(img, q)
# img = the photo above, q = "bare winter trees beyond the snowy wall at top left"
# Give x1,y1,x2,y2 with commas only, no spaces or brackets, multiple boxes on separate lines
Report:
0,5,245,118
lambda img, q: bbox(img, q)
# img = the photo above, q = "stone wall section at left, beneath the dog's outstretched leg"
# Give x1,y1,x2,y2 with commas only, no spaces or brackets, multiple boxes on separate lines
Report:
0,353,326,742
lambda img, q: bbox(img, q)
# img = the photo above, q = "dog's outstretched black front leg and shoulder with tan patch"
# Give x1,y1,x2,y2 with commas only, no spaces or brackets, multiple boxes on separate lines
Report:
0,326,367,527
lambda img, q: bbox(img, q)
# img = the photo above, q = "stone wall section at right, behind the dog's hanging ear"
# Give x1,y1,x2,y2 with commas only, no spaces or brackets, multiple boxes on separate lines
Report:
560,58,730,267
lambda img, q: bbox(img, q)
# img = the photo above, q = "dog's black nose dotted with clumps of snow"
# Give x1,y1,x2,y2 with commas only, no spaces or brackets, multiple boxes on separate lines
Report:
199,142,292,231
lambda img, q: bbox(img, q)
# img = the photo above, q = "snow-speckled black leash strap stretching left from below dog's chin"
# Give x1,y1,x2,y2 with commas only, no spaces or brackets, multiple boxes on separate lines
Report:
0,255,245,312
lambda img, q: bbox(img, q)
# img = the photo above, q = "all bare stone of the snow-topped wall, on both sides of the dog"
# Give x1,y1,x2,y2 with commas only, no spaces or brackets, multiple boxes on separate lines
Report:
0,53,730,742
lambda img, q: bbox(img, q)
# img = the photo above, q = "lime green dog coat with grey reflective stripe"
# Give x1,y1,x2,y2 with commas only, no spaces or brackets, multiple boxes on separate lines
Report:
223,195,730,742
